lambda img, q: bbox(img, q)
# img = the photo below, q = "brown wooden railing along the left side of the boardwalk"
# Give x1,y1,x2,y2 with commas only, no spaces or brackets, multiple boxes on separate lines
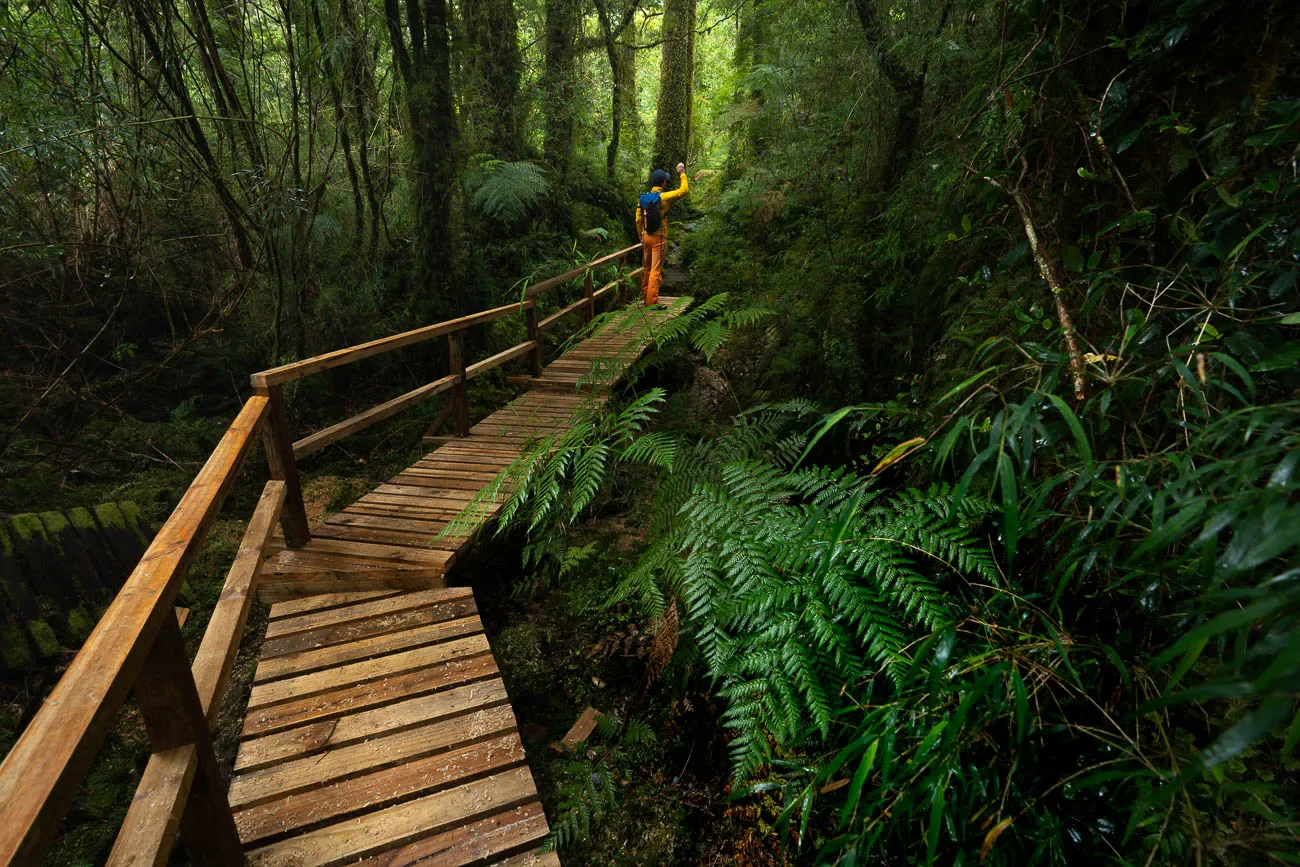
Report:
0,247,640,864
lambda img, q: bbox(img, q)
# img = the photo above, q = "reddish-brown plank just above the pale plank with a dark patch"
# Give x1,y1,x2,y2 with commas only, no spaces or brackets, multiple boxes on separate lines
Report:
241,653,498,737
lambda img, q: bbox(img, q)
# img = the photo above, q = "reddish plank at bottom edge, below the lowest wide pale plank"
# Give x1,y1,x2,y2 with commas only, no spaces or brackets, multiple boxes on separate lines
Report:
351,802,548,867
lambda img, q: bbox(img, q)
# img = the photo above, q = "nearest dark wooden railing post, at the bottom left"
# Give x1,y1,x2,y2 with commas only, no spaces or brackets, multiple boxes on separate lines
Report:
134,608,244,867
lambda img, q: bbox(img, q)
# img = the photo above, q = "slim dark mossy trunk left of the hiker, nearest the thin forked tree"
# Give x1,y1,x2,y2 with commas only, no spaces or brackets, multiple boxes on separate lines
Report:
542,0,582,196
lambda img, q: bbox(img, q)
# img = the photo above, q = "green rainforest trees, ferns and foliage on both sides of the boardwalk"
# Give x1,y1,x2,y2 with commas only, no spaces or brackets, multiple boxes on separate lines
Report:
0,0,1300,864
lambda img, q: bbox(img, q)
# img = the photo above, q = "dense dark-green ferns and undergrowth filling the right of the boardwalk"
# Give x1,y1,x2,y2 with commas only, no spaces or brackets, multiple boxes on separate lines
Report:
475,3,1300,864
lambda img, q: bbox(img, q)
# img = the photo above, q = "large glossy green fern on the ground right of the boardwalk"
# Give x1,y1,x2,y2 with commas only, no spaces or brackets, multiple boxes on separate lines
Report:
619,404,998,779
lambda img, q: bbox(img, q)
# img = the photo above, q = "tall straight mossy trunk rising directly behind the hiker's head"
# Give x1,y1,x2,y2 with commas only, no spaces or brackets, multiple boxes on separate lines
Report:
651,0,696,170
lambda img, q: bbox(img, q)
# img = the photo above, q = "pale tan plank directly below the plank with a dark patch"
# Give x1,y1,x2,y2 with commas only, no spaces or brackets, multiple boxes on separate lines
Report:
229,705,515,824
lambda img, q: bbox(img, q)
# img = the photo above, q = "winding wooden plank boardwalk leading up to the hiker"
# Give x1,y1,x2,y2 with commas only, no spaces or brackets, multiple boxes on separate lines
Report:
229,298,689,867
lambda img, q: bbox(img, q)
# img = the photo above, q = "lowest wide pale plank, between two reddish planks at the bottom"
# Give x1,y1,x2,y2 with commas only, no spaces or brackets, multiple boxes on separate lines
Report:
248,767,537,867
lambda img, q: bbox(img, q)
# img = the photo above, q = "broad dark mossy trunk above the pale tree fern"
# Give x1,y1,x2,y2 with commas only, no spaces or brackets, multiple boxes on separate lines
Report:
463,0,524,160
